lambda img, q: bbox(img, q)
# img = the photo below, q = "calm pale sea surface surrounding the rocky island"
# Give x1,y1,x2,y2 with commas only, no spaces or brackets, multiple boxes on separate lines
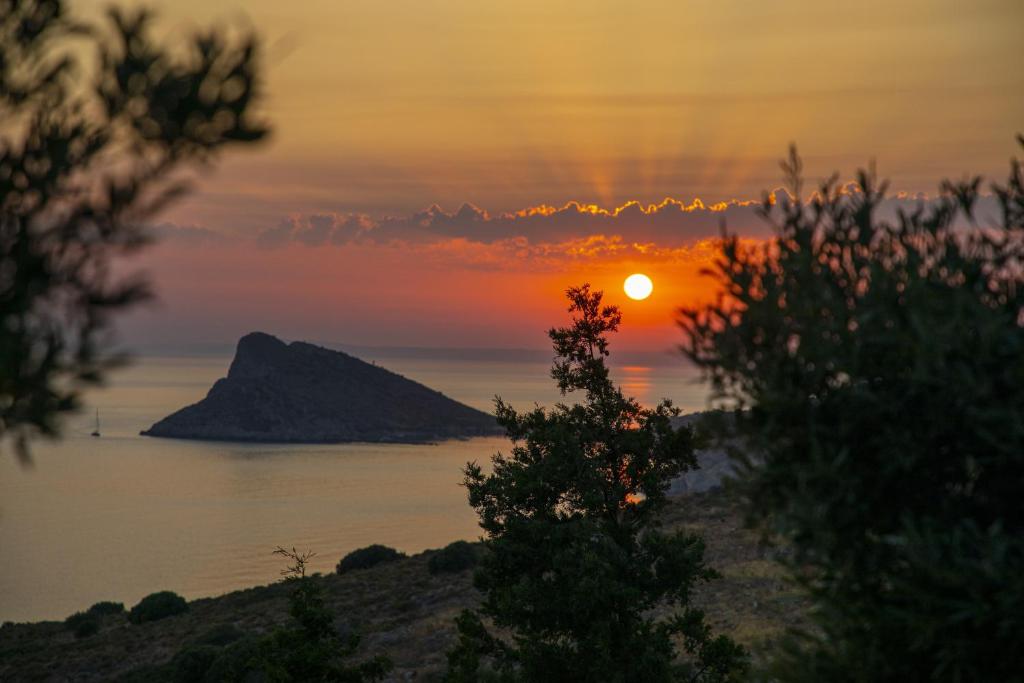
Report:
0,349,705,621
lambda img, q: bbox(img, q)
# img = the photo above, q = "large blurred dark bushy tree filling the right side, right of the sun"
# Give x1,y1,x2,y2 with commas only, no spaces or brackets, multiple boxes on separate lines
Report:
682,138,1024,681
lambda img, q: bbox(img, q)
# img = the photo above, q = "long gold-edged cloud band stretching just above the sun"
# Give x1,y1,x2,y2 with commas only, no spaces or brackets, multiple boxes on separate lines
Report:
163,185,998,266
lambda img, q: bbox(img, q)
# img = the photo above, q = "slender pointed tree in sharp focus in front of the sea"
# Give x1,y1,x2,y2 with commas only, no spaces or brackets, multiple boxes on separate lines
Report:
449,285,744,682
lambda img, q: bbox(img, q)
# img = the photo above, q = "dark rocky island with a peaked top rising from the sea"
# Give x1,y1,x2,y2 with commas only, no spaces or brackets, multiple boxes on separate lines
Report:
141,332,502,443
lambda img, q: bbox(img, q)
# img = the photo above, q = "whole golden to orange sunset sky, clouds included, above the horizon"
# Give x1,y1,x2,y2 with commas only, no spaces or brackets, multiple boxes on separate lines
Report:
83,0,1024,350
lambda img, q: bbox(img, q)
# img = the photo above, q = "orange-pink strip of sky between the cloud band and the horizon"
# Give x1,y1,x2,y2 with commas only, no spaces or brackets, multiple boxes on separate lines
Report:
123,231,724,350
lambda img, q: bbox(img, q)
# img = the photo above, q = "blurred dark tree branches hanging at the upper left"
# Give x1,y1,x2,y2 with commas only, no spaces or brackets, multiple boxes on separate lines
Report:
0,0,266,461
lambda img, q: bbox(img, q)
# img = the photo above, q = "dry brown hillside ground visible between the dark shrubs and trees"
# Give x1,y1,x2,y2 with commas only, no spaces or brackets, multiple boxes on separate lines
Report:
0,490,806,683
